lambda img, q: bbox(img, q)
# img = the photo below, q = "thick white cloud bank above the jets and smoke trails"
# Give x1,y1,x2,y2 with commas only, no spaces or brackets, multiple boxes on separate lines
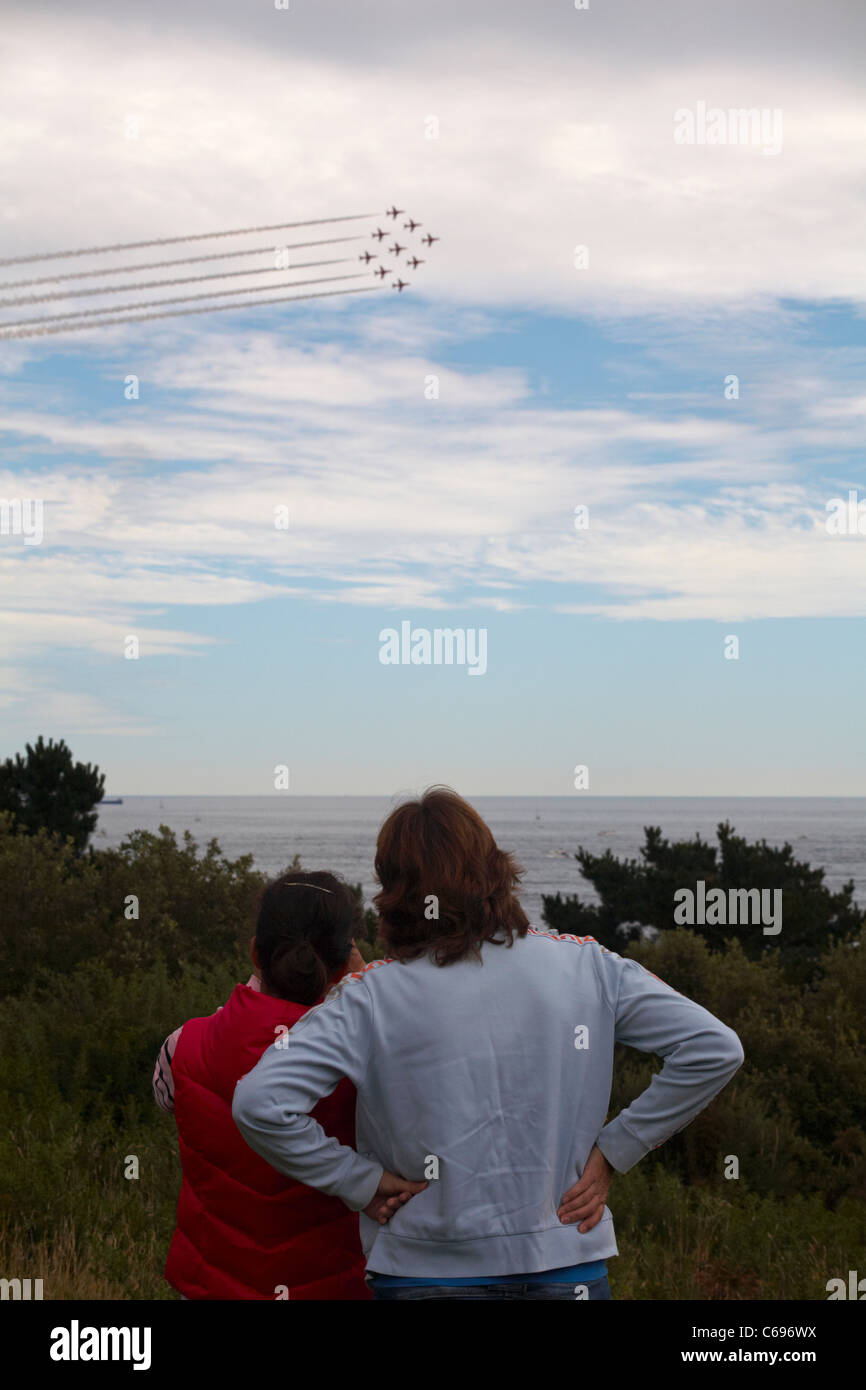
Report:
0,6,866,314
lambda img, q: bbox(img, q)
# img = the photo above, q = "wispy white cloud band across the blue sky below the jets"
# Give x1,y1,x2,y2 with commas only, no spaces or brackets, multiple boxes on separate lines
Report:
0,334,863,652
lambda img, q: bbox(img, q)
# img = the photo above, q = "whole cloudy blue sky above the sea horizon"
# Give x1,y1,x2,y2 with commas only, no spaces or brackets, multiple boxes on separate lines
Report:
0,0,866,796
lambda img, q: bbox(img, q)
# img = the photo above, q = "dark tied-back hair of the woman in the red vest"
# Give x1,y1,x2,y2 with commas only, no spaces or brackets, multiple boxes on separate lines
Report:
256,870,361,1004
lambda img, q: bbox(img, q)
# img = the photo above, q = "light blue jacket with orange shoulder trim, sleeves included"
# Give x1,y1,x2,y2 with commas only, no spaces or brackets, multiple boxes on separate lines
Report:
232,929,742,1279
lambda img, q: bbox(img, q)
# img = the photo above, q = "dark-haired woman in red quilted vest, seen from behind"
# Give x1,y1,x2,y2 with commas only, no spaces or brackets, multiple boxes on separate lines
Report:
153,872,371,1300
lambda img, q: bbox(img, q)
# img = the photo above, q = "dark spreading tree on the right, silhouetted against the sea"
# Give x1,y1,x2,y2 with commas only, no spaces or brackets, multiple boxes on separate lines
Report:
544,821,865,980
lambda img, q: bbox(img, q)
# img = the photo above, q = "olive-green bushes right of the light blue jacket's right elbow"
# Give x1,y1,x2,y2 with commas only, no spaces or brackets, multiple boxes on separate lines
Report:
612,929,866,1204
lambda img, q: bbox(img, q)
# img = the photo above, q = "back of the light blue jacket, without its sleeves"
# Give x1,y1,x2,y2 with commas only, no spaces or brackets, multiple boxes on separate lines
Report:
328,933,617,1277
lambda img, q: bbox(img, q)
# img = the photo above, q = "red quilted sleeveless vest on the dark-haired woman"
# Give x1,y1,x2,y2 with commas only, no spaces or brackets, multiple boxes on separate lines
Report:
165,984,371,1300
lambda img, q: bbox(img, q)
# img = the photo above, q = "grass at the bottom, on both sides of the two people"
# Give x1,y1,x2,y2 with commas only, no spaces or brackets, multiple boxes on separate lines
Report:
0,1113,866,1301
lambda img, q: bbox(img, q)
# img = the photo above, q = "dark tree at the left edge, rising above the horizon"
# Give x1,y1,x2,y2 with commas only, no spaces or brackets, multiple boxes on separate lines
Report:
0,737,106,853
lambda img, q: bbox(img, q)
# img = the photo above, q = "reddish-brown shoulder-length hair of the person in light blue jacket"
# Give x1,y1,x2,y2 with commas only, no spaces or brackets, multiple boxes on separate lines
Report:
373,787,530,965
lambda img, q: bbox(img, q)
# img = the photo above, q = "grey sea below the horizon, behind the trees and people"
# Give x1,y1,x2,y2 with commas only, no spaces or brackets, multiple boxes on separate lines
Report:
92,794,866,926
